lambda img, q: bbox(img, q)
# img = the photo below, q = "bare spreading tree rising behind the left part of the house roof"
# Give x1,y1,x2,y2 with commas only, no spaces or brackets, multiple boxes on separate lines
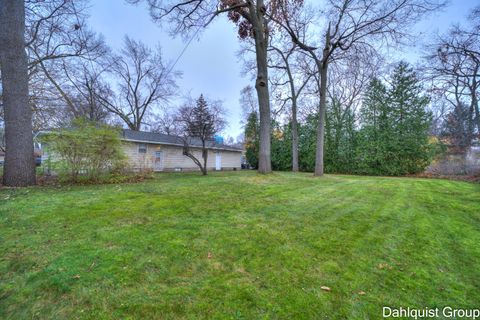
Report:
98,37,180,131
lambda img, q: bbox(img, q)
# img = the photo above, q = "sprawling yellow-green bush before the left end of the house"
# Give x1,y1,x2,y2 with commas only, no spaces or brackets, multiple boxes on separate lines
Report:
42,119,125,182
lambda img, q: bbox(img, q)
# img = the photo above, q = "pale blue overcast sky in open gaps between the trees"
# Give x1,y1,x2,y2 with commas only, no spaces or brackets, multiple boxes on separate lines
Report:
89,0,479,138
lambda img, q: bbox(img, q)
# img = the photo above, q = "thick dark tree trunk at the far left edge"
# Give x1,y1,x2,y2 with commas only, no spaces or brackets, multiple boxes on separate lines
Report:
0,0,35,187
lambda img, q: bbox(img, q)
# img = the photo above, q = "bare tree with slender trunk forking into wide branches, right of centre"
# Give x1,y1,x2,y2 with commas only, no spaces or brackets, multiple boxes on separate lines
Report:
272,0,442,176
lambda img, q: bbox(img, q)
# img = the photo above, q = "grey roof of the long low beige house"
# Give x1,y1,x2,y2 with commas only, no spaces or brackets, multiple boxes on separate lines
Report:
121,129,242,152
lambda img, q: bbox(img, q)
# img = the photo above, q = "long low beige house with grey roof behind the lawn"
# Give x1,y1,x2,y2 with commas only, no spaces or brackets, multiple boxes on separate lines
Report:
121,129,242,171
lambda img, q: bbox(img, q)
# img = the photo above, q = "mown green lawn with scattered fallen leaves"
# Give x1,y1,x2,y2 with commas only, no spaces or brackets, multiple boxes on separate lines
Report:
0,172,480,319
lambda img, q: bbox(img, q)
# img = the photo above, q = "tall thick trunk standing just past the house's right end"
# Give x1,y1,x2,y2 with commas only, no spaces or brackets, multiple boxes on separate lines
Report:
250,0,272,173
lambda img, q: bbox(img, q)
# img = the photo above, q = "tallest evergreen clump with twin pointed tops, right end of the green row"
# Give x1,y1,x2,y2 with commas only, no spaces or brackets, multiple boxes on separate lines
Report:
357,62,432,175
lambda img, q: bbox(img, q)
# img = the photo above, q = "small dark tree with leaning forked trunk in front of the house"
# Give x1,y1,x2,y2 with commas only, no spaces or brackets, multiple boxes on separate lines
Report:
176,95,225,175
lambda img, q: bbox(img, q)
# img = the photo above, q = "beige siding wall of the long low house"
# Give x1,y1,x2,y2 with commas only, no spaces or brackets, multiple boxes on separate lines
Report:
123,141,242,171
